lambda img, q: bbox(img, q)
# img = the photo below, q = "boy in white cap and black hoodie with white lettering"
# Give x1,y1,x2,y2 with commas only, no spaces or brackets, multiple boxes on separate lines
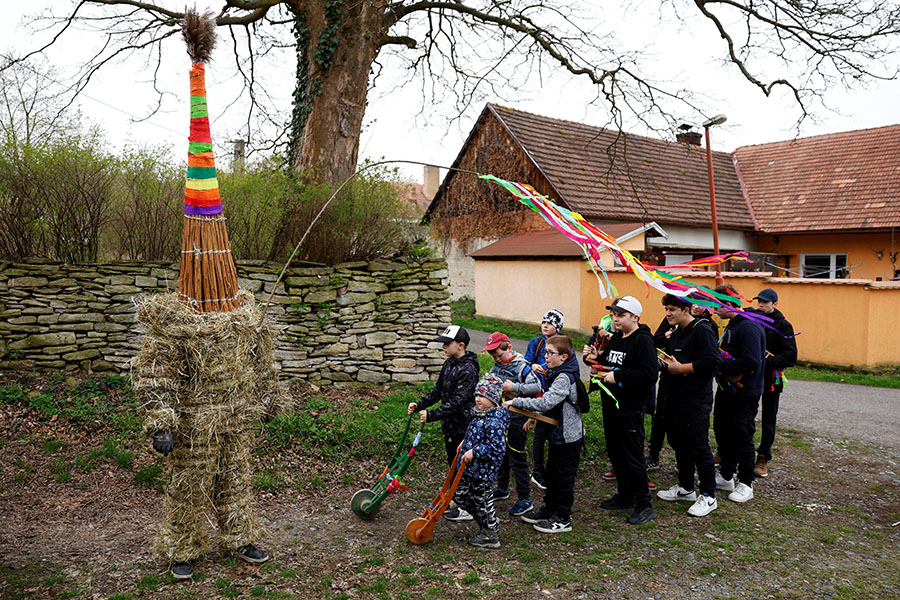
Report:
598,296,659,525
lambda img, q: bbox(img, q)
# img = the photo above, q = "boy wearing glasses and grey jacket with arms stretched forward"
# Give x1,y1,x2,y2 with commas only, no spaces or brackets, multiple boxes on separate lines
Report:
503,335,584,533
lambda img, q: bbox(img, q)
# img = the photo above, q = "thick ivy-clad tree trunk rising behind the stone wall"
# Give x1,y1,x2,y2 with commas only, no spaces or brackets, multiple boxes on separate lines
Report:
294,0,384,183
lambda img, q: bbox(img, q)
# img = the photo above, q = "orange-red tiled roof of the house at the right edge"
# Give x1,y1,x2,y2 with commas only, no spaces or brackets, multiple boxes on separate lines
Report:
736,125,900,233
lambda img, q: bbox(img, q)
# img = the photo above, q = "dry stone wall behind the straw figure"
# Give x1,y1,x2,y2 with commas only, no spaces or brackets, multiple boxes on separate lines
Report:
0,260,450,385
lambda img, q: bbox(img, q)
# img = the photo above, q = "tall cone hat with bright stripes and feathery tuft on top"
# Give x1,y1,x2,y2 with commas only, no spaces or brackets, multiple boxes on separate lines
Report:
178,10,240,312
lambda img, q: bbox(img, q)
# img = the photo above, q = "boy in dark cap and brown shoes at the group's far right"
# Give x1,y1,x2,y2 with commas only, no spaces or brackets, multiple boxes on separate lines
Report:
753,288,797,477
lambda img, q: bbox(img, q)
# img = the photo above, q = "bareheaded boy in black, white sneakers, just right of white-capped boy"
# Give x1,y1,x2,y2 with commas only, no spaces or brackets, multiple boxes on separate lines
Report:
656,294,721,517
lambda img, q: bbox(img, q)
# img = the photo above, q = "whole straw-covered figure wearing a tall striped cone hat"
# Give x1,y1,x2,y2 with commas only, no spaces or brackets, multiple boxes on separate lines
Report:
133,12,278,579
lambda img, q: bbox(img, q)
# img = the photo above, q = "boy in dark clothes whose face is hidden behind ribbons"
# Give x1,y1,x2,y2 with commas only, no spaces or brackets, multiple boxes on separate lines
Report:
713,285,766,502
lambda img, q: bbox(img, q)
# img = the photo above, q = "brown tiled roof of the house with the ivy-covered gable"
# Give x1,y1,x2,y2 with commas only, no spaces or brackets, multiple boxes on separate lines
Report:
485,104,753,230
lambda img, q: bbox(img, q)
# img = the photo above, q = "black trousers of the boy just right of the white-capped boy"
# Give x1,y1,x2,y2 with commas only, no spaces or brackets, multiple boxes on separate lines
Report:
666,398,716,496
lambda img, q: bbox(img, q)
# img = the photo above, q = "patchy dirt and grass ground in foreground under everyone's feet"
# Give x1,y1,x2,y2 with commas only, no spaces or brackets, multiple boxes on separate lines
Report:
0,376,900,600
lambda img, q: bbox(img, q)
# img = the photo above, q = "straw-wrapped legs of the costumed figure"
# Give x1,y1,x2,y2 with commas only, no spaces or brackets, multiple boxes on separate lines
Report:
156,428,259,562
